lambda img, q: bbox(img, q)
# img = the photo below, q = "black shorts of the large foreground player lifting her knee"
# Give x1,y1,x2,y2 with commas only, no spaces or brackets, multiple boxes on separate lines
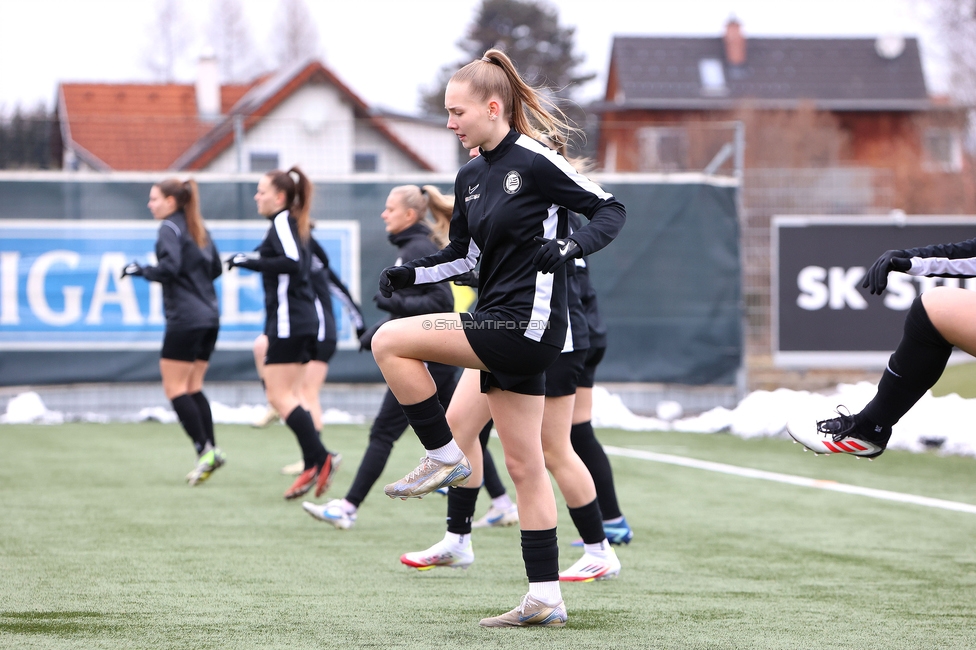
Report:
460,312,559,395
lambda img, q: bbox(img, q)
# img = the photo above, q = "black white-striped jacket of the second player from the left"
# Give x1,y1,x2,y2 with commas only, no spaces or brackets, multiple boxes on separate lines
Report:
248,210,319,339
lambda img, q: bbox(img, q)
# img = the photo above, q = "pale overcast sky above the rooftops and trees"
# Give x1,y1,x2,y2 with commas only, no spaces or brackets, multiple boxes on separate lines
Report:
0,0,946,113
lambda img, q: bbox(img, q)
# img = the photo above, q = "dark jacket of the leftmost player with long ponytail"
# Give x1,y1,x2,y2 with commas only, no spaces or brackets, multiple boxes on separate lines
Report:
143,210,222,331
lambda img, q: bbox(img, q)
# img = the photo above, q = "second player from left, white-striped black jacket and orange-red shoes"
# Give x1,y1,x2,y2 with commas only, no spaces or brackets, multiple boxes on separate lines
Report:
227,167,342,499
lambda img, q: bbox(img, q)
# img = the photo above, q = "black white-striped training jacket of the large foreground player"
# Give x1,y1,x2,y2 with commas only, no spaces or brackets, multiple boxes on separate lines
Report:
407,130,626,348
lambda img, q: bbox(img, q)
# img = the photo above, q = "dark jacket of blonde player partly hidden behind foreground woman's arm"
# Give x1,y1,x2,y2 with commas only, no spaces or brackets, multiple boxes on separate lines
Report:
373,222,454,318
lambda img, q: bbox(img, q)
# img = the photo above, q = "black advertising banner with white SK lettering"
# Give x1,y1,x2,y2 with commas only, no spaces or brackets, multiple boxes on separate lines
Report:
771,213,976,367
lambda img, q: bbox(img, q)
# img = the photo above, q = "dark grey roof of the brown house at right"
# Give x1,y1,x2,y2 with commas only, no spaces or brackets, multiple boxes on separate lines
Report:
606,37,928,108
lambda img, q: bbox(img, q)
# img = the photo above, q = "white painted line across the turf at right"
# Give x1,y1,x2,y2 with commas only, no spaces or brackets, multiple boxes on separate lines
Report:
603,445,976,515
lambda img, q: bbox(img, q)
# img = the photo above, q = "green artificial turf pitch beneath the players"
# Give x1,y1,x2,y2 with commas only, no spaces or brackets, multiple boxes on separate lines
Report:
0,423,976,650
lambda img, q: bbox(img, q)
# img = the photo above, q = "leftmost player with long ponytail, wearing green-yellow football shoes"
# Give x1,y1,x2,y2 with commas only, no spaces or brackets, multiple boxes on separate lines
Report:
122,178,226,485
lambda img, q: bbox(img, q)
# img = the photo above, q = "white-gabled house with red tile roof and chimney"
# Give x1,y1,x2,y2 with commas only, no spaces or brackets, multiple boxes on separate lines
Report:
57,58,463,177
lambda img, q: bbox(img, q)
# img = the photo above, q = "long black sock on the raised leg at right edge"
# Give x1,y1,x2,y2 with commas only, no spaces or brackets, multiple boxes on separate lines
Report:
855,297,952,444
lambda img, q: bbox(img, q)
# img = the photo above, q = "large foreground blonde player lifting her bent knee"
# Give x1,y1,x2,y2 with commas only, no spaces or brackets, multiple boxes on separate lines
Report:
373,50,625,627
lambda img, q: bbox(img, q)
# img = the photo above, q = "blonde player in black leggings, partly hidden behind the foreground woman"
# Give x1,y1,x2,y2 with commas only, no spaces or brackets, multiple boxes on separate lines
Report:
302,185,458,529
